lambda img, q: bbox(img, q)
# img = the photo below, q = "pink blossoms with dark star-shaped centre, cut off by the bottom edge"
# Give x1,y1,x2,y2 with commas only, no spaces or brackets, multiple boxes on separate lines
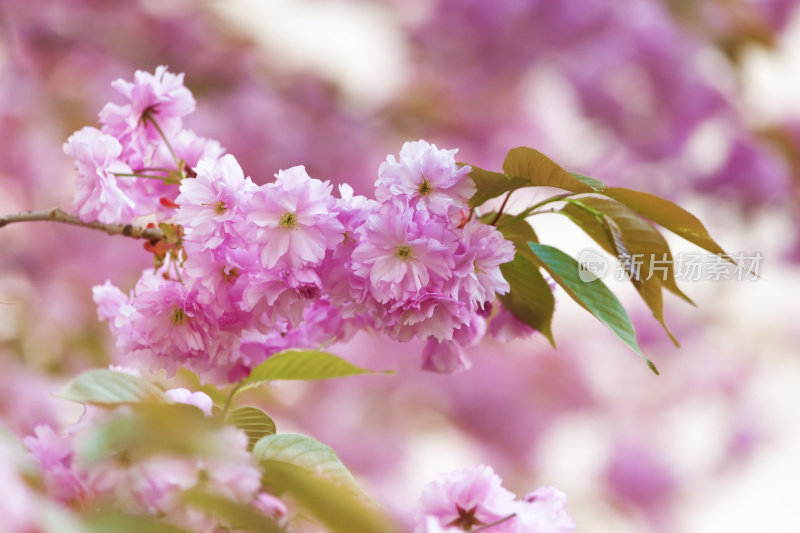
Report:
416,465,575,533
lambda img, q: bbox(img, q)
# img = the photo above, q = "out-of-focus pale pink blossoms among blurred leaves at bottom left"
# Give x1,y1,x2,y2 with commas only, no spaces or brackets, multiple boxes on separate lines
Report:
24,378,288,533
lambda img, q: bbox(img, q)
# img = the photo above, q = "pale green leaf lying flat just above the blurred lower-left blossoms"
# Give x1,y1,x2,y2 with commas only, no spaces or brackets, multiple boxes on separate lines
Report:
59,369,167,405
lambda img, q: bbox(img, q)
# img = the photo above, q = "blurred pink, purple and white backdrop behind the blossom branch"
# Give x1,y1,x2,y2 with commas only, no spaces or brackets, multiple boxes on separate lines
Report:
0,0,800,533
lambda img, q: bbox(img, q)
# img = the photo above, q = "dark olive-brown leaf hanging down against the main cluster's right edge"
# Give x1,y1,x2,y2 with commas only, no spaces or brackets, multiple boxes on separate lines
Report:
498,252,556,346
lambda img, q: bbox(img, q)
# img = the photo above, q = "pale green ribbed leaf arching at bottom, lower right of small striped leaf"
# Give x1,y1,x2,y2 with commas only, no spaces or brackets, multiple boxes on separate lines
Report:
253,433,364,495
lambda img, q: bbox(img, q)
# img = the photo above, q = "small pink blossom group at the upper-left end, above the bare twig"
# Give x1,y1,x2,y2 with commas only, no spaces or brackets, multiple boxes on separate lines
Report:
64,66,223,224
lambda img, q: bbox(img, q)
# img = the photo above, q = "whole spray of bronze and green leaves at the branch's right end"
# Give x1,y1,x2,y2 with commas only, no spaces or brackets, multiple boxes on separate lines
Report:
462,147,730,373
